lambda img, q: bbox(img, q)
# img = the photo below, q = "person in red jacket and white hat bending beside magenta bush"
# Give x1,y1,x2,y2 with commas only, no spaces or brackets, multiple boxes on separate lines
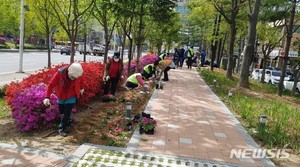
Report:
43,63,84,136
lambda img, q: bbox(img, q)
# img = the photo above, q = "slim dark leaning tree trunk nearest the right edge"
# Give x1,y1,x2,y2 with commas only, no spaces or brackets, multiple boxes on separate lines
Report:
277,0,297,96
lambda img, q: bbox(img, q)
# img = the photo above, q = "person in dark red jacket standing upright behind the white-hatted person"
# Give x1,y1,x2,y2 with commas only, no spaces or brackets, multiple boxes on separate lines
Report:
103,52,123,96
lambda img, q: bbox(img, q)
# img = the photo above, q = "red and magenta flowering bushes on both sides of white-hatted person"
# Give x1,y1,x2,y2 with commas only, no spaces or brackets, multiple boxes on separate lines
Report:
5,62,104,131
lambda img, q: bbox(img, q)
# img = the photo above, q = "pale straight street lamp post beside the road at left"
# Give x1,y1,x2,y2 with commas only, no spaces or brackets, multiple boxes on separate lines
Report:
19,0,25,73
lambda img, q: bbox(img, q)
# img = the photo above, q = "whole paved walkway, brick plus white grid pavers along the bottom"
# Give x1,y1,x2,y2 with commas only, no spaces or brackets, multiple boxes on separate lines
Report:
0,68,275,167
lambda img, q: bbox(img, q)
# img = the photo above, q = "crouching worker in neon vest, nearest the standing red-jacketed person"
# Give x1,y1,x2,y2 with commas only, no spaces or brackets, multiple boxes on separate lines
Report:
125,73,148,92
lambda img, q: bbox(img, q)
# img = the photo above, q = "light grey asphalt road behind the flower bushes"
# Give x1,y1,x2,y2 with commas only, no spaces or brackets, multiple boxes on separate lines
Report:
0,52,109,74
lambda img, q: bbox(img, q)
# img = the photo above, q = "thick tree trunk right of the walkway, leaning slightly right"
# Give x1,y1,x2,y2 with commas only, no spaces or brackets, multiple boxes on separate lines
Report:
238,0,260,88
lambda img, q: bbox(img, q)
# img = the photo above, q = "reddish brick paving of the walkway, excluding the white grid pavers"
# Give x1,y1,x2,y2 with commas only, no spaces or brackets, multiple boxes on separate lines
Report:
137,68,273,167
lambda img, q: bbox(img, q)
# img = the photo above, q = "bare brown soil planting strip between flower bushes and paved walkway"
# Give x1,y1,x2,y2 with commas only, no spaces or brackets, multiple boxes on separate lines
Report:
0,89,151,155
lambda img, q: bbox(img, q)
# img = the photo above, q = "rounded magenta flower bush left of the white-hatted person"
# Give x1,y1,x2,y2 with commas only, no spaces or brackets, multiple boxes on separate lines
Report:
11,83,59,132
